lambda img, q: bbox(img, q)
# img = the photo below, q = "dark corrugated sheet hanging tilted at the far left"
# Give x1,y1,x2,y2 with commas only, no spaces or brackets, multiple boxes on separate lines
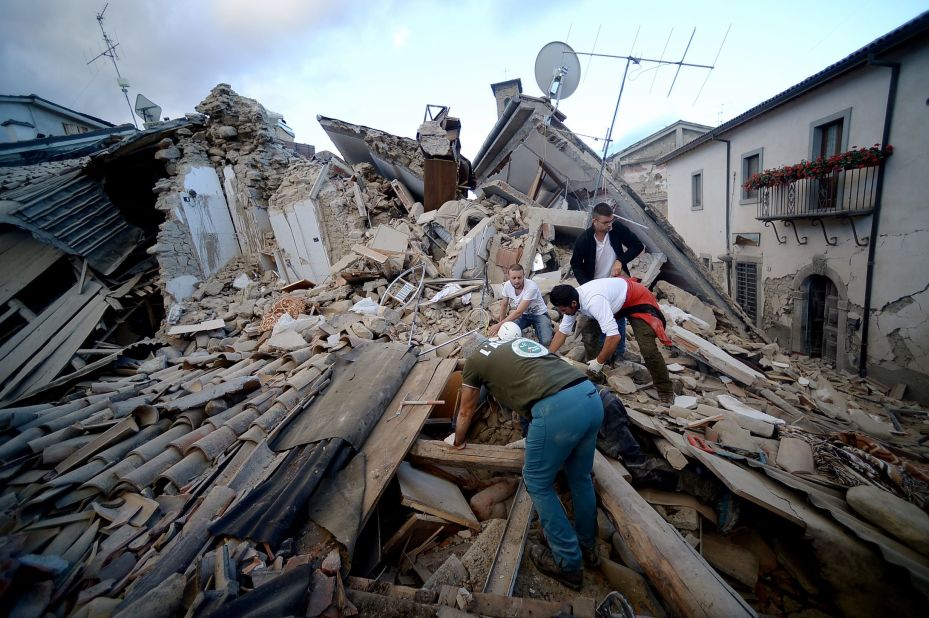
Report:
0,170,142,275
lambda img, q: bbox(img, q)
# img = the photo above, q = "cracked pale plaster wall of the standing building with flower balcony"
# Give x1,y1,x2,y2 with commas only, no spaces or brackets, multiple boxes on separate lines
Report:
668,44,929,397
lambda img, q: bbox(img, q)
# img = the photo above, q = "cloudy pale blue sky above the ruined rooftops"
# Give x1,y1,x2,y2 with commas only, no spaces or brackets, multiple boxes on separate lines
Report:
0,0,926,156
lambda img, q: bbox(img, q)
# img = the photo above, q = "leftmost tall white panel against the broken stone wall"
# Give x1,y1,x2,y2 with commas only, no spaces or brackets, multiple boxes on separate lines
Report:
179,165,240,277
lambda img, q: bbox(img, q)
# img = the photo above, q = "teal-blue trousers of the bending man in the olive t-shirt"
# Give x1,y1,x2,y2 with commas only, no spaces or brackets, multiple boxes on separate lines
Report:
523,380,603,571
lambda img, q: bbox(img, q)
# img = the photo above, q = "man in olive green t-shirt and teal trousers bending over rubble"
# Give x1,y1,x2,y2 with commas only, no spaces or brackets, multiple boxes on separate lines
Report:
454,338,603,590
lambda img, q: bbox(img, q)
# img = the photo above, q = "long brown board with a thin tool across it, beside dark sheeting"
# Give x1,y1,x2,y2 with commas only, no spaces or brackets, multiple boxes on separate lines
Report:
361,359,456,526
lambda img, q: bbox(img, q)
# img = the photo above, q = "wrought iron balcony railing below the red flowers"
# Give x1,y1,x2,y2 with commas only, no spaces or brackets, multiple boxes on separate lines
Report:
756,165,880,221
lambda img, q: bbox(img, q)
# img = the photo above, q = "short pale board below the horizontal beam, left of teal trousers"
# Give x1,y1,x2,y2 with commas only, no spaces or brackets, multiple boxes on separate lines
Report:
397,461,481,530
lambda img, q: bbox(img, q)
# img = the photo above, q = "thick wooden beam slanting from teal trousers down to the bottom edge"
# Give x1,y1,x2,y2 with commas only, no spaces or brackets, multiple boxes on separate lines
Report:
593,452,756,618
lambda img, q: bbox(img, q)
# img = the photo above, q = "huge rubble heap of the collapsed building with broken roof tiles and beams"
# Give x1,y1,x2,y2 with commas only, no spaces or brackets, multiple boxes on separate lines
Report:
0,85,929,616
